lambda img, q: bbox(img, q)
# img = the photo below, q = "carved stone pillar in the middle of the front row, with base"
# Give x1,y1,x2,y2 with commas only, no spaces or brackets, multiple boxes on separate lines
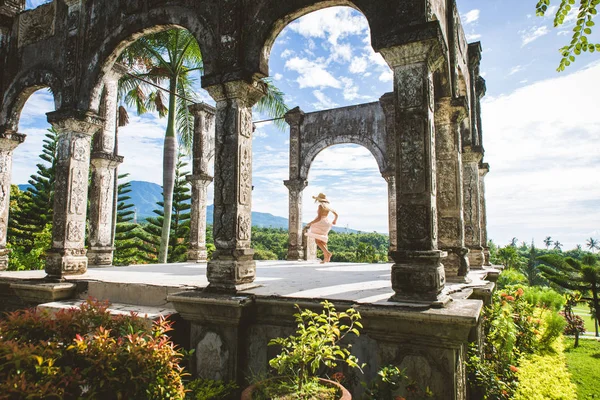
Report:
206,81,265,291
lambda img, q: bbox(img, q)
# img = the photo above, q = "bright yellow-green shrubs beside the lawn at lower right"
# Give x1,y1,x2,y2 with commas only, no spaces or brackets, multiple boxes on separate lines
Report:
467,286,574,400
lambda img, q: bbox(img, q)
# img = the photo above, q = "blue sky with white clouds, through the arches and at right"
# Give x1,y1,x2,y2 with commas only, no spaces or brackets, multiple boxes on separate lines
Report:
13,0,600,248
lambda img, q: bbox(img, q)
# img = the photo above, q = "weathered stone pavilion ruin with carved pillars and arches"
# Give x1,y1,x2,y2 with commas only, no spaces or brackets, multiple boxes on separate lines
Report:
0,0,489,399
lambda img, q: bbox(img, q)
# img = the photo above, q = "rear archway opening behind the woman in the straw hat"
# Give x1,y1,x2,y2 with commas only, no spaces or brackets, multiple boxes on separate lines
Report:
302,144,390,263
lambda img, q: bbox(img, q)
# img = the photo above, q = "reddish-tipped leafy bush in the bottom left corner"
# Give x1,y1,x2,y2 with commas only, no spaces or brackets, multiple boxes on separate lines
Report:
0,300,185,400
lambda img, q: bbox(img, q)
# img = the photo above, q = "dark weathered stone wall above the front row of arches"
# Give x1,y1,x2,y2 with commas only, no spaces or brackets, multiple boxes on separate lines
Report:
0,0,466,129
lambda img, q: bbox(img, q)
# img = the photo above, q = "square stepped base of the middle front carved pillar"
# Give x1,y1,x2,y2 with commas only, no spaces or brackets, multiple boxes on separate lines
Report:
206,249,257,292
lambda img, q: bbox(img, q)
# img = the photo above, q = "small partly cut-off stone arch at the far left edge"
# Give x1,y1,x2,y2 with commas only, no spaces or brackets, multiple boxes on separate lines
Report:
0,66,63,132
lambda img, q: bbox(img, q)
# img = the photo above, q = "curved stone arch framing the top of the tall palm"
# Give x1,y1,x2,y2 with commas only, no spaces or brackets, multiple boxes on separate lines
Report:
79,6,217,111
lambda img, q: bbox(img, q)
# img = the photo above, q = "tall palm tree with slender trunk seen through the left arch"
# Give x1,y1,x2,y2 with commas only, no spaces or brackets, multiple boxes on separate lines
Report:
119,29,287,263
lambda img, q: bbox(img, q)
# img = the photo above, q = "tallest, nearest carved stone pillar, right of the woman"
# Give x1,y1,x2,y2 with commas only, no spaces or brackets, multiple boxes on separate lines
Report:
381,39,449,306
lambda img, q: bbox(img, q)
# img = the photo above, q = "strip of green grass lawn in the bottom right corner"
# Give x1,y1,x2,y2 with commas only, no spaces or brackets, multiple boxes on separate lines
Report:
565,338,600,400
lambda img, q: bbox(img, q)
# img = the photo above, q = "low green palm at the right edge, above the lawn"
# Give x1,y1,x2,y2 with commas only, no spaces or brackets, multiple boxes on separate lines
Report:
538,254,600,336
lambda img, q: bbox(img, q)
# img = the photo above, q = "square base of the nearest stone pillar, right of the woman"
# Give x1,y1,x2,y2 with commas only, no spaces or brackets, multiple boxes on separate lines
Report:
390,250,451,307
